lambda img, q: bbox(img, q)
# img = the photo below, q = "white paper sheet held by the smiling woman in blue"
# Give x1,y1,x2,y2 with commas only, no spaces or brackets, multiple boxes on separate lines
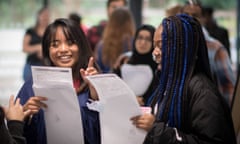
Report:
32,66,84,144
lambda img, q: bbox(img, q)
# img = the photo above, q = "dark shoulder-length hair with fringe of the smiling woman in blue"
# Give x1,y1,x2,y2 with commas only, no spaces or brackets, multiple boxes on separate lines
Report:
42,18,92,80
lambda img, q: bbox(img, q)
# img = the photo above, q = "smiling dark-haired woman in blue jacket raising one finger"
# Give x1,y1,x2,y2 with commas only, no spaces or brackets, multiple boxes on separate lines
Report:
17,19,100,144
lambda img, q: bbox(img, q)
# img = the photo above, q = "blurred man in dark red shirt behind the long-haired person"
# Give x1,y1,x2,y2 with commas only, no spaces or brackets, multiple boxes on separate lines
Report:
87,0,127,50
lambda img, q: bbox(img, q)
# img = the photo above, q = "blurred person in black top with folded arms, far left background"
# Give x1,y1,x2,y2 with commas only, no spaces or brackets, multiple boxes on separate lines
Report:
23,7,49,81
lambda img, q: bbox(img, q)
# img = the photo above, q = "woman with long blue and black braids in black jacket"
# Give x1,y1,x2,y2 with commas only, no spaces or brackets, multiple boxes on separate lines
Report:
132,14,236,144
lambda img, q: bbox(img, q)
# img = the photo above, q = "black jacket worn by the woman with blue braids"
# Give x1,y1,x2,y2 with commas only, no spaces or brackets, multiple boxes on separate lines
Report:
144,74,236,144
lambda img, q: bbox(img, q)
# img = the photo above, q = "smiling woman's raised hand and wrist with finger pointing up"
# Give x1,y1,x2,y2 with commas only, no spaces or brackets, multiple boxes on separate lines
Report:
80,57,98,100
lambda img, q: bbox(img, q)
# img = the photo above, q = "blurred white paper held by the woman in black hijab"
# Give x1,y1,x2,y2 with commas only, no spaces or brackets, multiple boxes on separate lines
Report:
121,64,153,96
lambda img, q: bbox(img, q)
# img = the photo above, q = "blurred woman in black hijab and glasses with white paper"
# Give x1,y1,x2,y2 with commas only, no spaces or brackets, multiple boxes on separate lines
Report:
114,24,157,105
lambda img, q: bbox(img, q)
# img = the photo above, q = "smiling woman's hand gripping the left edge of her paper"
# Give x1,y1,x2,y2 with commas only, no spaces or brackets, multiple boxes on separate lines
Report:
23,96,47,115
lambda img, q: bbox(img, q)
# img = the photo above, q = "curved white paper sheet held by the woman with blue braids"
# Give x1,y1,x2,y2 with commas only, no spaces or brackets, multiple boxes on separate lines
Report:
87,74,146,144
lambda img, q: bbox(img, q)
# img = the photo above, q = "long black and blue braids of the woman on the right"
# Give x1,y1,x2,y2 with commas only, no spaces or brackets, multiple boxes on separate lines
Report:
148,14,212,128
